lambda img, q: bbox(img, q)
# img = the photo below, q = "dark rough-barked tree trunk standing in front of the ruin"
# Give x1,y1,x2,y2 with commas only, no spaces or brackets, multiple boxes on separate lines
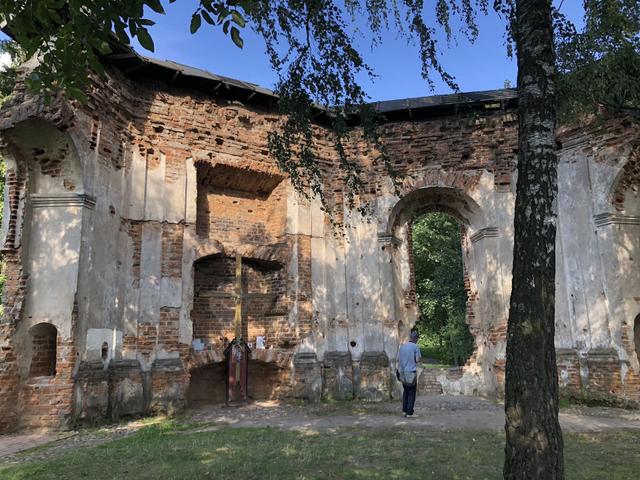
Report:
504,0,564,480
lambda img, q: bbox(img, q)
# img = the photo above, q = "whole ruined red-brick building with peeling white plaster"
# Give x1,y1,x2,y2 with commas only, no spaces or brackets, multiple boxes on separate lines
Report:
0,43,640,430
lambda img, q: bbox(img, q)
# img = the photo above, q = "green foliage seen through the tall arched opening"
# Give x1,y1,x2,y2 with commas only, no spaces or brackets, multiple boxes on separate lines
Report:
413,212,473,365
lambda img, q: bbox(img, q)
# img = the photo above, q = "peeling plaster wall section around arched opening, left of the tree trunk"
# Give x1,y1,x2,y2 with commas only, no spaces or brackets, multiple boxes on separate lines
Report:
308,110,517,398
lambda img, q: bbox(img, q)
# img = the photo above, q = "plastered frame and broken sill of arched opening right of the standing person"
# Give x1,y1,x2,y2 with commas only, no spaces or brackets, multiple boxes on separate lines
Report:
387,186,512,395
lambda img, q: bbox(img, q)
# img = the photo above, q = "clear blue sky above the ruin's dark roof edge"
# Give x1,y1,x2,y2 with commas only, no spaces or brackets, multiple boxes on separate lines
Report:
1,0,583,101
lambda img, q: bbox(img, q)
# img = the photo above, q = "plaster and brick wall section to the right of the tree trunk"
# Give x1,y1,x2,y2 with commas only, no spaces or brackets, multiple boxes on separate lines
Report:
556,116,640,401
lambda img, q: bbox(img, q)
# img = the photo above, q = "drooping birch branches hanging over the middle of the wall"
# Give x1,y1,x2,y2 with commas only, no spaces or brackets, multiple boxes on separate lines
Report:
245,0,488,213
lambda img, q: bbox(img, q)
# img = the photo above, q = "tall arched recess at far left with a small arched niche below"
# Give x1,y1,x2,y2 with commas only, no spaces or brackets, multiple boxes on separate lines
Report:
0,120,86,427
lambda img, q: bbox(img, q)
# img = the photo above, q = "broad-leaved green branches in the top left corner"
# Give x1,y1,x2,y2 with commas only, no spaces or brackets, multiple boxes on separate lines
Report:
0,0,247,100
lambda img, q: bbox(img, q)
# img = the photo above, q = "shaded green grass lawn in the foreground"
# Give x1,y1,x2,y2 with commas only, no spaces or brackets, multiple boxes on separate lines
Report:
0,421,640,480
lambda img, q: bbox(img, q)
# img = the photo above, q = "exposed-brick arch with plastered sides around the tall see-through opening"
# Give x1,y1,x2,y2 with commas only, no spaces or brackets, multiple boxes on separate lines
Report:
385,178,506,393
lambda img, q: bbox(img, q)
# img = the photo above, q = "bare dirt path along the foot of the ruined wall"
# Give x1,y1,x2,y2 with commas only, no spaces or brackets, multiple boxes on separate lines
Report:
0,395,640,463
